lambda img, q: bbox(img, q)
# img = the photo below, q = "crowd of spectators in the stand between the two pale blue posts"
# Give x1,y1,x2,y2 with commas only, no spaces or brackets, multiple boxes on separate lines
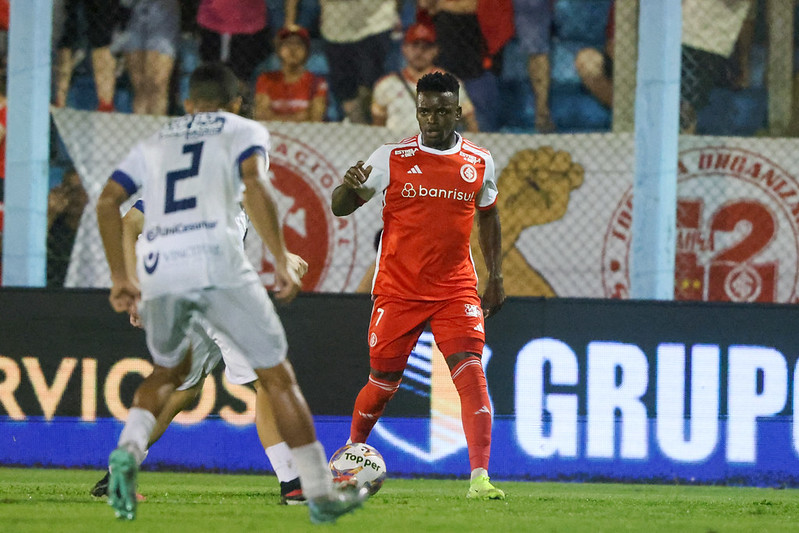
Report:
53,0,576,133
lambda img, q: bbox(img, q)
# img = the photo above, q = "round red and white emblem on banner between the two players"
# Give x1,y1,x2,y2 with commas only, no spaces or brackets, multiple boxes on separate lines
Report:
247,134,356,292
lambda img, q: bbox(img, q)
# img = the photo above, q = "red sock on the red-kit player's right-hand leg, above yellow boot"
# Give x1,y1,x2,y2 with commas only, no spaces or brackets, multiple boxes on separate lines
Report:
452,357,491,470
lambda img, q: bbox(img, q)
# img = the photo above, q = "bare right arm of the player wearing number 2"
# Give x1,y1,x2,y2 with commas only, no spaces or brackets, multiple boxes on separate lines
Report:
241,154,308,302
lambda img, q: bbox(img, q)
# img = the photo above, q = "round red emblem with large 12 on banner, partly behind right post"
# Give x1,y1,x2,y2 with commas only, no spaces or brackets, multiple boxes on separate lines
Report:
602,146,799,302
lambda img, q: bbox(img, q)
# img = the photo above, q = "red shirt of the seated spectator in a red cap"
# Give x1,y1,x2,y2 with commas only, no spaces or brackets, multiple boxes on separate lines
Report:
255,70,327,115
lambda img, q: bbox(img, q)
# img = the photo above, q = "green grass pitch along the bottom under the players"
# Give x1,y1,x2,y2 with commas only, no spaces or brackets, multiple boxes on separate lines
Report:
0,468,799,533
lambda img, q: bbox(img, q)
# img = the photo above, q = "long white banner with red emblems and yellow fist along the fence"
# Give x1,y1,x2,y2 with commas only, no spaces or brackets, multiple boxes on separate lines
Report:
53,109,799,302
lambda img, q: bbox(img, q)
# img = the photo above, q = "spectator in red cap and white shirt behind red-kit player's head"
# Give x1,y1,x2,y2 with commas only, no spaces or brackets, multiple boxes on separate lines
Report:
371,23,478,137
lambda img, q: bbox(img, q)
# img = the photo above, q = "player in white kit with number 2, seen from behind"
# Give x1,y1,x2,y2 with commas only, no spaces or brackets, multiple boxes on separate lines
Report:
97,64,366,523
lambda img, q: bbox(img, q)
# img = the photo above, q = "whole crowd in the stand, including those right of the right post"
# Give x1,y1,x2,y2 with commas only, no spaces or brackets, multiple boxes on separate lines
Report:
45,0,788,133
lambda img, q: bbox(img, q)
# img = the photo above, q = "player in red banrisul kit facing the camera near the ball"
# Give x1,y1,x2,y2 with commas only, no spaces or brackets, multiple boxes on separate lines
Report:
332,72,505,500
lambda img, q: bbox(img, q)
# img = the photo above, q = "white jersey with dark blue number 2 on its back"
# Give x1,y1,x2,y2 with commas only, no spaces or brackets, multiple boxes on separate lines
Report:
111,111,269,300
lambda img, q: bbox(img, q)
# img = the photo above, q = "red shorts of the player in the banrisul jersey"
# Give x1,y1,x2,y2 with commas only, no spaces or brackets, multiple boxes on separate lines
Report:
368,294,485,372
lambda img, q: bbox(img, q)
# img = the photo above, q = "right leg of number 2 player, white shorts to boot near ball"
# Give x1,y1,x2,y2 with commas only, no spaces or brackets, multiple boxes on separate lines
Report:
203,282,367,523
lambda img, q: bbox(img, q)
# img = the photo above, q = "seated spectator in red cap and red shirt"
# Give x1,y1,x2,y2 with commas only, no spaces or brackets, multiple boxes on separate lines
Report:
255,26,327,122
